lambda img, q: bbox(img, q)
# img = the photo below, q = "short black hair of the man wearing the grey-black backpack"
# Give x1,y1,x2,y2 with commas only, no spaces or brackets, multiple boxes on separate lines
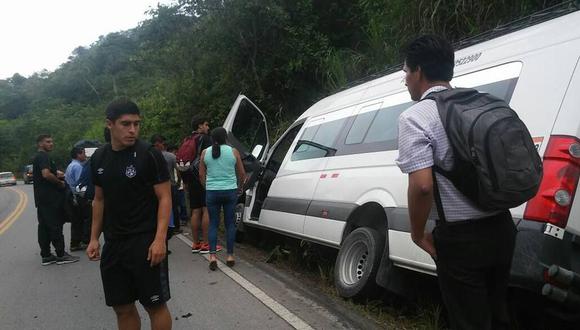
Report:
403,34,455,81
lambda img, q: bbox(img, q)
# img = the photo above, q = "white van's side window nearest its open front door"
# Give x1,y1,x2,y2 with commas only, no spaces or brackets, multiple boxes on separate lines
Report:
291,118,348,161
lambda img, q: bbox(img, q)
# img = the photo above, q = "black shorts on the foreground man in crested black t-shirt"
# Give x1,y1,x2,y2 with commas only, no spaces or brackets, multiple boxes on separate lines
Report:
101,233,171,307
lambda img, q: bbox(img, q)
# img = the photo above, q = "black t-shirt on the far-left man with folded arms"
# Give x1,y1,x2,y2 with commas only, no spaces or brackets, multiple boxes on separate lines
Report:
32,151,64,207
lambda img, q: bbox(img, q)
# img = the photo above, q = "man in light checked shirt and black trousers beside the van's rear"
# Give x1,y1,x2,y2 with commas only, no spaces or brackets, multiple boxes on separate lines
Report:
397,35,515,329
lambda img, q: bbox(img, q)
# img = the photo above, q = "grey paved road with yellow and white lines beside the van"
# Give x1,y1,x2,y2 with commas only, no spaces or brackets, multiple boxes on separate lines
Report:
0,184,372,329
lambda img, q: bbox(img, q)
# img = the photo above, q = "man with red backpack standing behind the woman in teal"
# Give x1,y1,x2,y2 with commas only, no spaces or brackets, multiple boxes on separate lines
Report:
176,116,222,253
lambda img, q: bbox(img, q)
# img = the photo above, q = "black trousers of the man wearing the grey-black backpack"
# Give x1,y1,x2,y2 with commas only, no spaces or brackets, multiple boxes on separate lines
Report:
433,211,516,330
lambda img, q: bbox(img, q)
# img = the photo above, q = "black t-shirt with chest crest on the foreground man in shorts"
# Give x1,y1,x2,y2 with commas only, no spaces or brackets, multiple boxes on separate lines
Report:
91,140,169,240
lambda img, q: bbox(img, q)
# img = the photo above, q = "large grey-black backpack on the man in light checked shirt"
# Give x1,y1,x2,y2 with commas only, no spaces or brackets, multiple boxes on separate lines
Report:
426,88,542,210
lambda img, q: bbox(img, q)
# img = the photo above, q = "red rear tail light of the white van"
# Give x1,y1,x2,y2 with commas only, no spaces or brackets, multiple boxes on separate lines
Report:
524,136,580,228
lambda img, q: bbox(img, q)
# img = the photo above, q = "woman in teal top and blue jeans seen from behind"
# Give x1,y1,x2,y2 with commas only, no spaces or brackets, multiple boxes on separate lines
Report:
199,127,246,270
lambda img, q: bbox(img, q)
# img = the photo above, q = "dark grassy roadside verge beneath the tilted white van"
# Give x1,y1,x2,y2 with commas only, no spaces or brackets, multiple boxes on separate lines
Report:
236,230,446,330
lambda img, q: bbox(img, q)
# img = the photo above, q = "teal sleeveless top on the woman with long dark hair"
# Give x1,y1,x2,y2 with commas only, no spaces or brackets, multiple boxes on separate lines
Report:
203,144,238,190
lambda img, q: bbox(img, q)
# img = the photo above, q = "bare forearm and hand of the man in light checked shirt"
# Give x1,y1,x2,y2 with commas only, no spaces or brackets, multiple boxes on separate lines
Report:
407,167,436,257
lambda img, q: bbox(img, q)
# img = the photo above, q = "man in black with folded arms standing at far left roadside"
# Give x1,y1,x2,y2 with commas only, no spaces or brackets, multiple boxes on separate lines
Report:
32,134,79,266
